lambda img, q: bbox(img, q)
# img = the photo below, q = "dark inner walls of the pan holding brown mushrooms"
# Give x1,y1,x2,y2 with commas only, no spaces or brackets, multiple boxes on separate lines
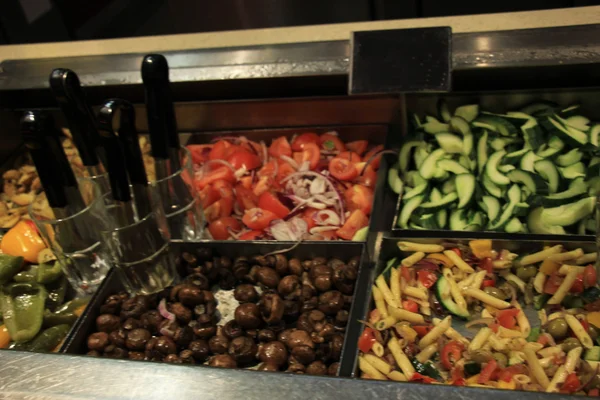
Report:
61,241,369,376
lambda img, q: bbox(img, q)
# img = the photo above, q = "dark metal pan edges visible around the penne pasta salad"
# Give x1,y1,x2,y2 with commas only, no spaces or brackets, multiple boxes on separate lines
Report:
346,232,596,388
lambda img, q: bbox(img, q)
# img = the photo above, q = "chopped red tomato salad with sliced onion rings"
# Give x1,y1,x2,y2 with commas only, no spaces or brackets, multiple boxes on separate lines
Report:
188,131,383,241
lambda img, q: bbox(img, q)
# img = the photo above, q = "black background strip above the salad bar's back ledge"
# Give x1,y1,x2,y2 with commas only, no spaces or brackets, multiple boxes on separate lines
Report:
0,0,600,44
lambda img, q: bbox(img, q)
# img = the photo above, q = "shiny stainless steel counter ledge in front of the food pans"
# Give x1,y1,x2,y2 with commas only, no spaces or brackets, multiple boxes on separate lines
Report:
0,351,566,400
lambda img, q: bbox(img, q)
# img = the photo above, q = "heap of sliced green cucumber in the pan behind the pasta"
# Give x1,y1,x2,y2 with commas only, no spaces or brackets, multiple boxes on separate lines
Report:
388,101,600,235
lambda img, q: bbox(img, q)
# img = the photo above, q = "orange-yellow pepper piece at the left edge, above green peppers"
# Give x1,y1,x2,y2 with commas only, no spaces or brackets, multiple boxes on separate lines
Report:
0,221,46,264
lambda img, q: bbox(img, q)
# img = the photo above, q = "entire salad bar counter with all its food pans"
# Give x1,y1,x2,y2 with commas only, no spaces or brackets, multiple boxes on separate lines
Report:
0,22,600,399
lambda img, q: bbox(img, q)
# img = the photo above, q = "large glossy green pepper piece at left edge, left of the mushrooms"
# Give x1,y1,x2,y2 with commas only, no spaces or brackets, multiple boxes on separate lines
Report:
0,282,47,343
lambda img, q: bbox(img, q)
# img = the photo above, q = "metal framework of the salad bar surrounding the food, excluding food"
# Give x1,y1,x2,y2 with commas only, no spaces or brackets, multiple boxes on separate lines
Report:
0,25,600,399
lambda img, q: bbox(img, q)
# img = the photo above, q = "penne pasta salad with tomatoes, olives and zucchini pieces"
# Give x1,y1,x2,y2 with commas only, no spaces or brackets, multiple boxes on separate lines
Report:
358,240,600,396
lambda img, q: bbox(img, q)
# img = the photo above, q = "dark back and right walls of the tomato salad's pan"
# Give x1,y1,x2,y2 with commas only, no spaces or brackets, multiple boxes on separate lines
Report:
186,124,395,241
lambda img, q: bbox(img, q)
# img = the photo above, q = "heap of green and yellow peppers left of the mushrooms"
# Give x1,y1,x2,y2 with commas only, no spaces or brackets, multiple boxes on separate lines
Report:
0,220,89,352
